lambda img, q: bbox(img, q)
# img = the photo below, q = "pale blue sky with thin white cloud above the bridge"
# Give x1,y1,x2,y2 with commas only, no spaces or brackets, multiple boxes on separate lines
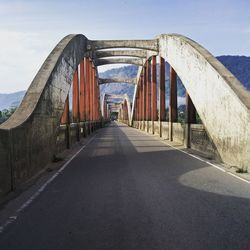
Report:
0,0,250,93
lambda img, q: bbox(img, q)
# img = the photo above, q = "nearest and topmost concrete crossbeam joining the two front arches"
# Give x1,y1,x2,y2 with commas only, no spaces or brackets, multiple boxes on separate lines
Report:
87,39,158,51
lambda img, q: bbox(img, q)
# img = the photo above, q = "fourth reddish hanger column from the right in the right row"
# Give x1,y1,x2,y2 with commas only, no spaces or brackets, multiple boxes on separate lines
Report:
151,56,157,134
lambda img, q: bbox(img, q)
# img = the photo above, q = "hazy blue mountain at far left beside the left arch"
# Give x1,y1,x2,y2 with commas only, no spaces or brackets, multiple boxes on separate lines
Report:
0,90,26,110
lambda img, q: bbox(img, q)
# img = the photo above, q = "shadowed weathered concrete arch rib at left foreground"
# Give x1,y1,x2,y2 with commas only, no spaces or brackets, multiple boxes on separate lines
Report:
0,35,87,196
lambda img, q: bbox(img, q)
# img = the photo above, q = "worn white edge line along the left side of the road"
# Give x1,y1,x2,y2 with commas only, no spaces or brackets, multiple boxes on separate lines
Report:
0,135,96,233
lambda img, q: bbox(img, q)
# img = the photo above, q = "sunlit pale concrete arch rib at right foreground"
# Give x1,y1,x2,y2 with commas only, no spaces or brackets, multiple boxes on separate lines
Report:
158,34,250,167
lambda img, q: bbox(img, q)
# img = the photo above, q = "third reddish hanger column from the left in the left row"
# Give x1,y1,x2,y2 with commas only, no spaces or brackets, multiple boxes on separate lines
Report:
80,60,86,122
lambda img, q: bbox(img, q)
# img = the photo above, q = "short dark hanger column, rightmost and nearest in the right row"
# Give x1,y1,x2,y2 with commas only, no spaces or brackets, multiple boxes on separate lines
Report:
185,92,196,148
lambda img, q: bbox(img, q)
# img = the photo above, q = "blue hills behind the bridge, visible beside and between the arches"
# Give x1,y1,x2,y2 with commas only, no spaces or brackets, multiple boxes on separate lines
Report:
0,56,250,110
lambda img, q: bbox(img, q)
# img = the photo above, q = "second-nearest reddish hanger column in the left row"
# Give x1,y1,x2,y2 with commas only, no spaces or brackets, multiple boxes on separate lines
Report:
72,69,80,141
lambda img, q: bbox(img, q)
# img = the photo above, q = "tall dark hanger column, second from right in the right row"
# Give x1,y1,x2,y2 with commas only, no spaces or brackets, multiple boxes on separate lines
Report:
169,66,178,141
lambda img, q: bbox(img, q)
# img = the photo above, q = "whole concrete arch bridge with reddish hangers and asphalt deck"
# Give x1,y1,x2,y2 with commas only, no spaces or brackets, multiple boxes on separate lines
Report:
0,34,250,249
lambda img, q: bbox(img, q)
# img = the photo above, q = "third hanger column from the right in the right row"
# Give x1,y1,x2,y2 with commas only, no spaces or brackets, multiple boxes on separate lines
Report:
159,57,166,137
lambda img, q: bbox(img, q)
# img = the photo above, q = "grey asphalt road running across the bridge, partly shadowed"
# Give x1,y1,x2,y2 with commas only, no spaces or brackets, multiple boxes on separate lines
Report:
0,123,250,250
